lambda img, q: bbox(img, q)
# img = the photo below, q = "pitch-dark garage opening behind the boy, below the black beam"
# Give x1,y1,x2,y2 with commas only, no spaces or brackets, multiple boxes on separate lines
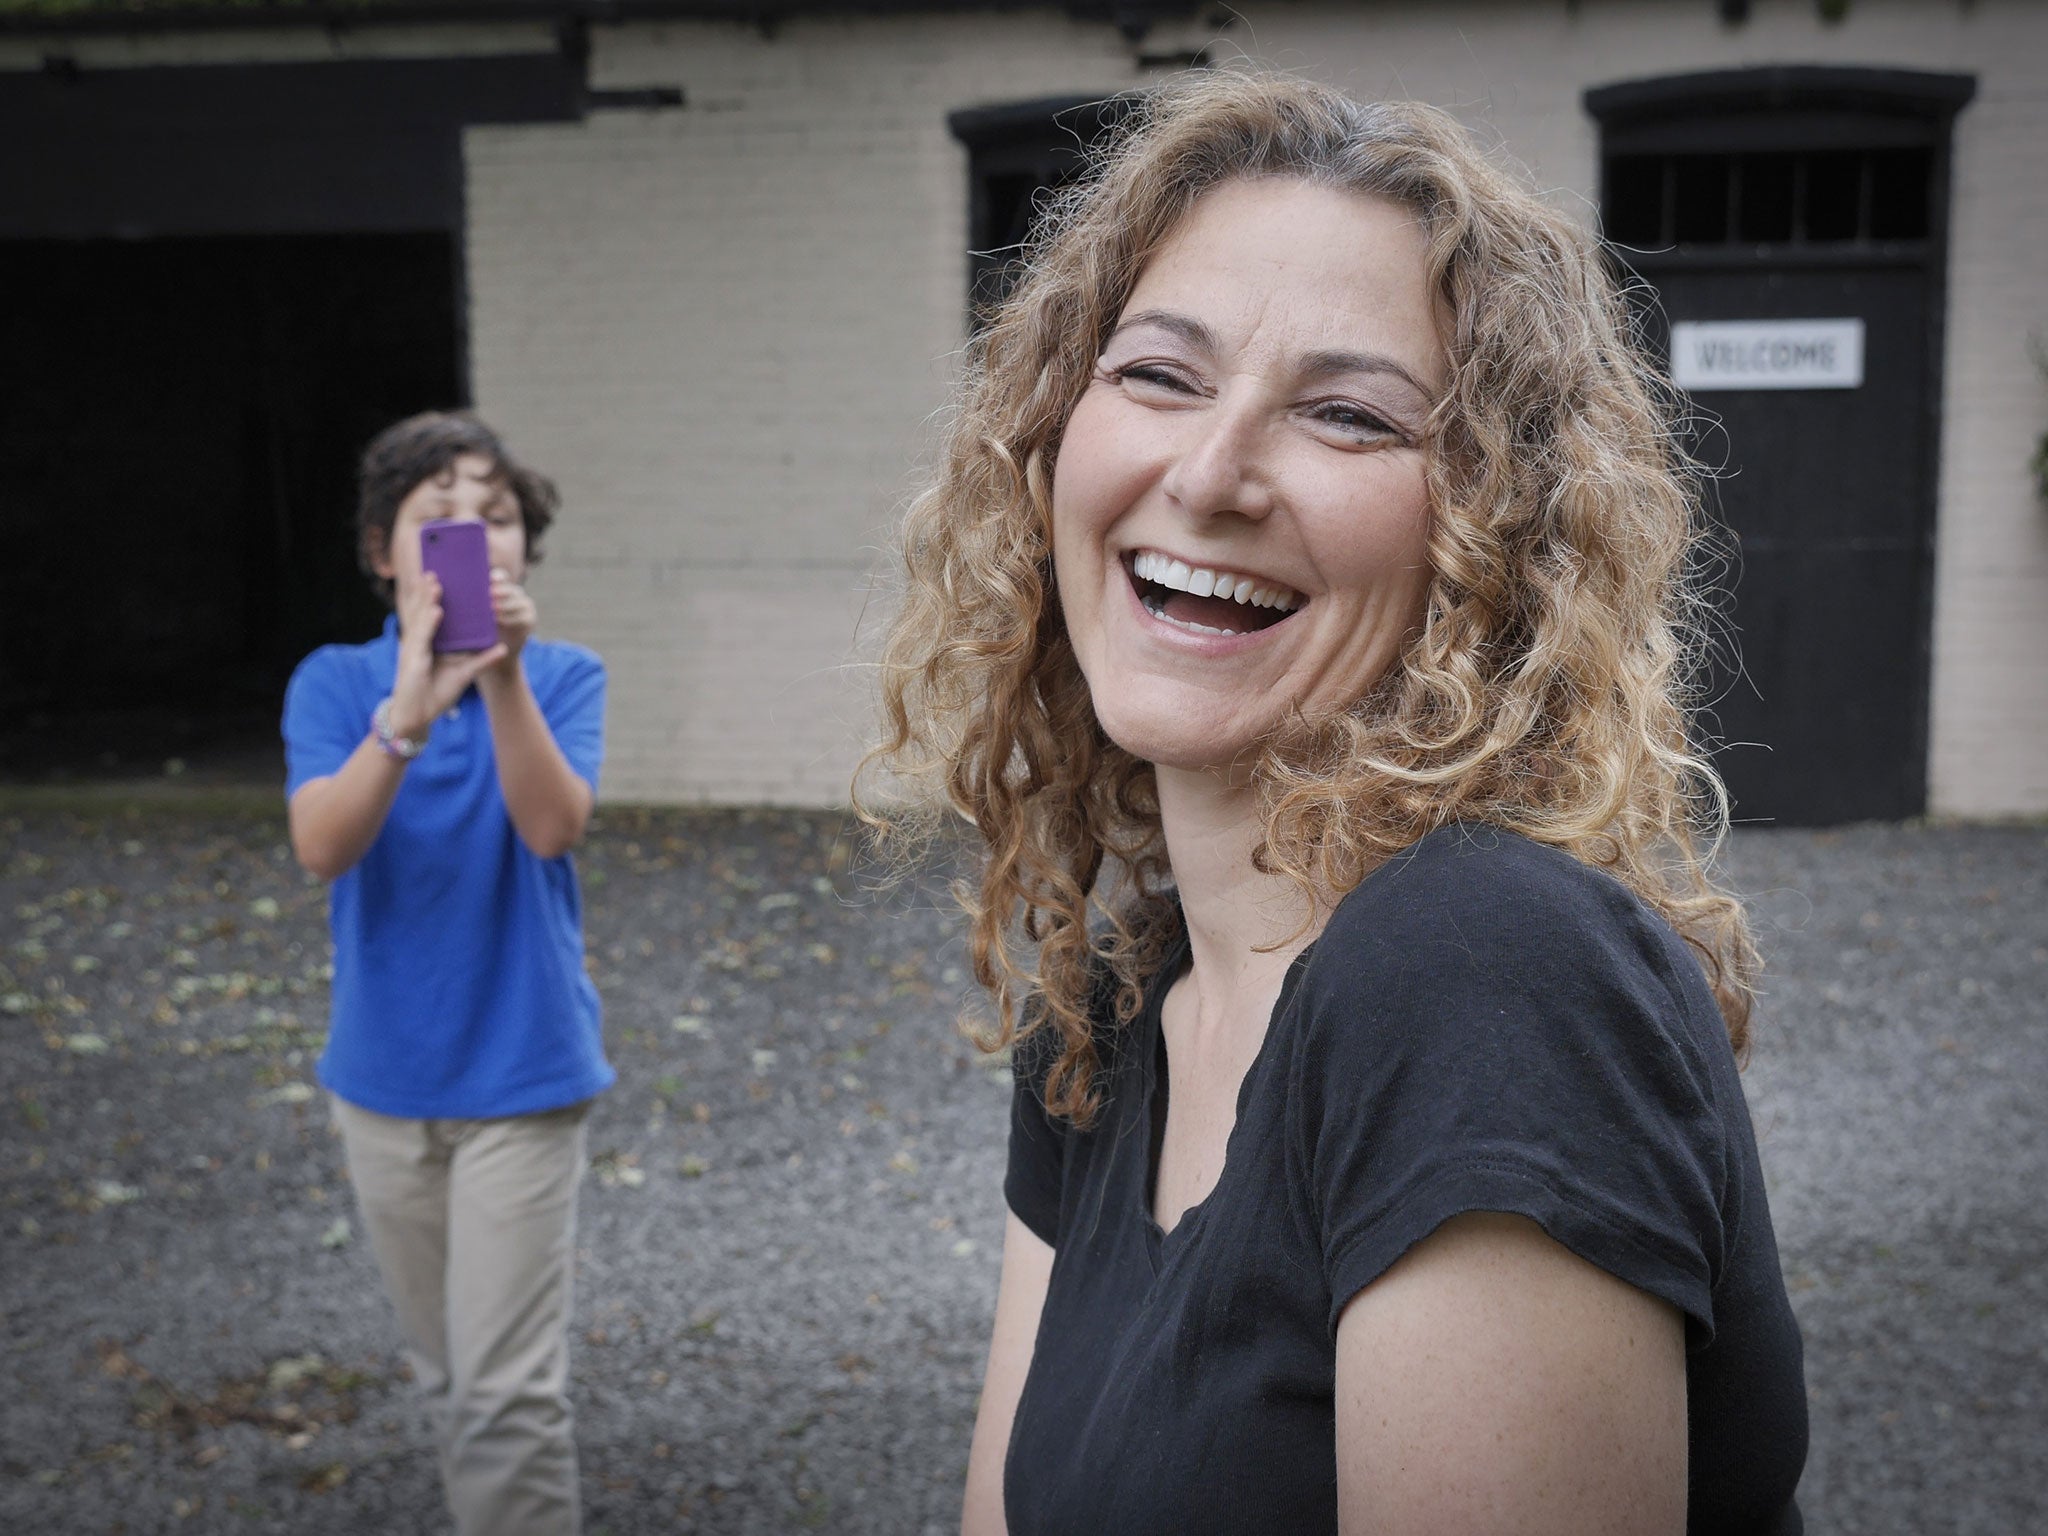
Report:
0,233,463,776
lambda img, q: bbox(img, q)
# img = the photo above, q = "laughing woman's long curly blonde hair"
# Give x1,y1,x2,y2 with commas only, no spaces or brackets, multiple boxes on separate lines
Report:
856,72,1755,1124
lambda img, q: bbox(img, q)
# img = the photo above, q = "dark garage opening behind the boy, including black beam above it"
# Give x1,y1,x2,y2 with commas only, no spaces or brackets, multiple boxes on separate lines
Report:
0,52,590,782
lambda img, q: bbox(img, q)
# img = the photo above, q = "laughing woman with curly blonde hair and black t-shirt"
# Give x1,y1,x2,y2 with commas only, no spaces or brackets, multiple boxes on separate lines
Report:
874,74,1806,1536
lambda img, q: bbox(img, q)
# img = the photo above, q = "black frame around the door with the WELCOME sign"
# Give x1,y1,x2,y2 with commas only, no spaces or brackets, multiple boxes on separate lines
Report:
1585,66,1976,815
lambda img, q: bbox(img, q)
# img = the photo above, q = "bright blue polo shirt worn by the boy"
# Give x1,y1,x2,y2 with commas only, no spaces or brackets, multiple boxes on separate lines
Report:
285,618,616,1120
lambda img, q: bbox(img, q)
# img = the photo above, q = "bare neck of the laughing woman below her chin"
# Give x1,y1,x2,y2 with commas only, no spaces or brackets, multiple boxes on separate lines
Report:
1157,768,1329,1018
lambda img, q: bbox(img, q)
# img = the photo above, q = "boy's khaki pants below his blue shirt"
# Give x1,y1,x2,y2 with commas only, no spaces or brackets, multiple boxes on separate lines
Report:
330,1096,588,1536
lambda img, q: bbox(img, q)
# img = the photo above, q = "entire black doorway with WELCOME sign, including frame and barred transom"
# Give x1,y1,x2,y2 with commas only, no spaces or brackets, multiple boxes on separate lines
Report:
1587,66,1974,825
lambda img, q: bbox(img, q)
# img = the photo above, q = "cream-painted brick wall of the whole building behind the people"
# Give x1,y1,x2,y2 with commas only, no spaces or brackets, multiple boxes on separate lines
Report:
0,0,2048,815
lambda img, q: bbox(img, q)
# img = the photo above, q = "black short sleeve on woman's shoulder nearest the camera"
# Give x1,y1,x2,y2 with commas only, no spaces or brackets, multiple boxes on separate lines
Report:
1298,829,1729,1348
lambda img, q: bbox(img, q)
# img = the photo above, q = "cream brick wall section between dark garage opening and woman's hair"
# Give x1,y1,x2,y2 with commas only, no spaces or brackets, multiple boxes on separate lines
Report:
467,16,1179,803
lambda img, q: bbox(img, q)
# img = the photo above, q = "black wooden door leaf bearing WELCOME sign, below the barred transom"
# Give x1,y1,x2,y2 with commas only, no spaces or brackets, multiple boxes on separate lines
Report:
1649,264,1933,825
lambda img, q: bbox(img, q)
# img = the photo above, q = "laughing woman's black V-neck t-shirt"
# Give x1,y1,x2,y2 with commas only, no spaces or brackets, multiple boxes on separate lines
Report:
1004,825,1806,1536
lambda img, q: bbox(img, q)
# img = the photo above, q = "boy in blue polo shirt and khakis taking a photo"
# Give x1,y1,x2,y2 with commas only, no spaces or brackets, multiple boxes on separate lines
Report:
285,412,614,1536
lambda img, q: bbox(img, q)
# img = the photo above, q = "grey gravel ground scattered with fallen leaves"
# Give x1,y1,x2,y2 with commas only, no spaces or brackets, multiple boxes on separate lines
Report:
0,806,2048,1536
